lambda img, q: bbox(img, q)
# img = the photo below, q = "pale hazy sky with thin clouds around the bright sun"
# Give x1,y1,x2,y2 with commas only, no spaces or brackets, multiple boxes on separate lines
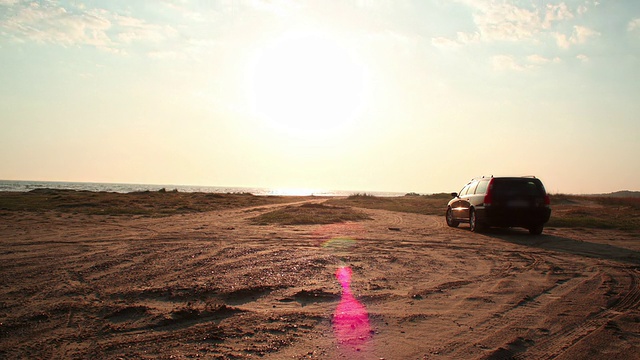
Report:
0,0,640,194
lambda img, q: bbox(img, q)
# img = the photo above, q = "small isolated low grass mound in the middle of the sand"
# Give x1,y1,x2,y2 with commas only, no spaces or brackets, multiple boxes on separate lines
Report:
251,204,370,225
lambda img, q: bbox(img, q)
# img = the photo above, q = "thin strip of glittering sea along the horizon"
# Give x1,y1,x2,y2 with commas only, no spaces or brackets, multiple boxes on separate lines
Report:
0,180,404,197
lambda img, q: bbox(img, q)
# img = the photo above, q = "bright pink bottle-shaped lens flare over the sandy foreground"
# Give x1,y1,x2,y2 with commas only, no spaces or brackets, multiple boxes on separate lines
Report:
333,266,371,345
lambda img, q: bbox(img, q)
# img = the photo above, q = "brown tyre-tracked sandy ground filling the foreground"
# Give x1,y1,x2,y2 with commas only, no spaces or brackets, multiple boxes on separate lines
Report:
0,198,640,359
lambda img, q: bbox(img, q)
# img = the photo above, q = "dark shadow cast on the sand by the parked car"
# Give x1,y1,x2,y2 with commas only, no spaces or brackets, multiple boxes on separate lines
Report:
468,228,640,265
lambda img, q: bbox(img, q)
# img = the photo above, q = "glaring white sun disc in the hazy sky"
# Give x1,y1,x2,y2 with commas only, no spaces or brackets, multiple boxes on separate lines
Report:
249,31,365,135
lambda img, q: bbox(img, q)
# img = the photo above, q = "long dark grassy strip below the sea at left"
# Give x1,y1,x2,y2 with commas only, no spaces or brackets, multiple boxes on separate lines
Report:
0,189,303,217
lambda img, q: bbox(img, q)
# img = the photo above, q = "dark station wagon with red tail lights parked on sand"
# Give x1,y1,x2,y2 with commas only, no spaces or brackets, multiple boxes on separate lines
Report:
446,176,551,235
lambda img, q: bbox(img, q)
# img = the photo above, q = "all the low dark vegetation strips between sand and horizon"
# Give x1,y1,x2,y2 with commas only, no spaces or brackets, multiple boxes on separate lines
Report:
0,189,640,232
